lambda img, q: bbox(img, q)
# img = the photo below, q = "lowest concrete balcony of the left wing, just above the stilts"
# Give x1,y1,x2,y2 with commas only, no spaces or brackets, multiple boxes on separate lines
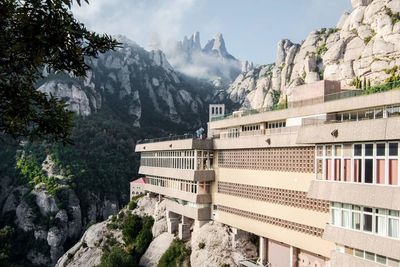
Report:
166,199,211,221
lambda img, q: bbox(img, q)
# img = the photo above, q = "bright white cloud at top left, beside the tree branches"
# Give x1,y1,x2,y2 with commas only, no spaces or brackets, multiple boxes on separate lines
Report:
72,0,200,48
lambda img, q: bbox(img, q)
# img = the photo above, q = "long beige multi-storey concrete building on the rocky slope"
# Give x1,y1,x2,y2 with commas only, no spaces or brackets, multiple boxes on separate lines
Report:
136,82,400,267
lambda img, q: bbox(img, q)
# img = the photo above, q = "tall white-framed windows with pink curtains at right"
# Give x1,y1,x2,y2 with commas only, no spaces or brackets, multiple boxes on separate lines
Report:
316,142,400,185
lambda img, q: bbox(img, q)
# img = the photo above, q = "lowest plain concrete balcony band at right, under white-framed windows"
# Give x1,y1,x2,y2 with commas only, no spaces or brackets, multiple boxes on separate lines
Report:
322,224,400,260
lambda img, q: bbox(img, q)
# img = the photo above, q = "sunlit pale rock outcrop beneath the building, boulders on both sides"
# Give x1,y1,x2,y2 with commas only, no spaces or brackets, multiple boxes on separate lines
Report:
56,196,257,267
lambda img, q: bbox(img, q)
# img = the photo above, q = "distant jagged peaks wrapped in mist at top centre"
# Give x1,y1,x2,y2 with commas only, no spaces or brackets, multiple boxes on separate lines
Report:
167,32,242,87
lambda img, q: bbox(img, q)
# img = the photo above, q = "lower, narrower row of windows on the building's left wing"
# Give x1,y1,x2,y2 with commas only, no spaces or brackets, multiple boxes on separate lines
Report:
145,176,210,194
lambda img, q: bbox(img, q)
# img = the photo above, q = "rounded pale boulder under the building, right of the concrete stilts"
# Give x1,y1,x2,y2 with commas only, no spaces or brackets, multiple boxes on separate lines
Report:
190,222,257,267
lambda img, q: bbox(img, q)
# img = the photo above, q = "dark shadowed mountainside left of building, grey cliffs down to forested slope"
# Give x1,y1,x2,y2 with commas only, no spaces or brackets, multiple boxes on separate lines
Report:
0,36,219,266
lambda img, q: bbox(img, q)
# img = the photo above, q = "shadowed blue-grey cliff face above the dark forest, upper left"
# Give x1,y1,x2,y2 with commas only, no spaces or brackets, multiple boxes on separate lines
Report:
39,36,212,128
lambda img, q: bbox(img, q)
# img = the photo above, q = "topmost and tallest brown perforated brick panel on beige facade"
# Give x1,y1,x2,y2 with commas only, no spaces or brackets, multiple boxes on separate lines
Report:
218,147,315,173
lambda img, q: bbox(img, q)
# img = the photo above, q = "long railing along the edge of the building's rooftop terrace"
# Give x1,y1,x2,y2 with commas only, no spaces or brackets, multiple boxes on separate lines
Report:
211,81,400,121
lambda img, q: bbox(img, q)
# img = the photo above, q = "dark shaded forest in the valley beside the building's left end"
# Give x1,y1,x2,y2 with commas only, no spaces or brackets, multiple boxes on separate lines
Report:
49,112,159,206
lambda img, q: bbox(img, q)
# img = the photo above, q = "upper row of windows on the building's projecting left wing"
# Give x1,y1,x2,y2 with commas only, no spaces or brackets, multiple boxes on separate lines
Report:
140,150,214,170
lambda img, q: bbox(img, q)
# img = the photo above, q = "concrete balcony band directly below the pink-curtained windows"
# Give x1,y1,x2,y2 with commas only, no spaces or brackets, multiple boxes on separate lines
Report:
307,180,400,210
